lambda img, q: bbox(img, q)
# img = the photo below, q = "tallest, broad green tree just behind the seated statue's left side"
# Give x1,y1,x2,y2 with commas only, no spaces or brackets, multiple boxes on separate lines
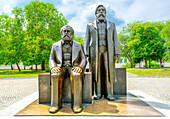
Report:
24,1,68,70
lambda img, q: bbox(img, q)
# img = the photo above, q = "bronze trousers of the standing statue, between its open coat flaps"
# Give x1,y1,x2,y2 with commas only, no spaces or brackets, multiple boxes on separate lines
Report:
95,45,113,97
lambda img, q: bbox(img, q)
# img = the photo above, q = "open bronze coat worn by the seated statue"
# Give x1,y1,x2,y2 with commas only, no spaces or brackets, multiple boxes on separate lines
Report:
49,40,86,70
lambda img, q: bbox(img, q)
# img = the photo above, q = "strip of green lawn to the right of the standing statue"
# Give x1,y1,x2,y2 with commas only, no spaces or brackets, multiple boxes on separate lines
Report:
127,68,170,76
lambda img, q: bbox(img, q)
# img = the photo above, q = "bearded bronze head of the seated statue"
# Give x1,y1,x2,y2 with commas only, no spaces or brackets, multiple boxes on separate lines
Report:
60,25,74,41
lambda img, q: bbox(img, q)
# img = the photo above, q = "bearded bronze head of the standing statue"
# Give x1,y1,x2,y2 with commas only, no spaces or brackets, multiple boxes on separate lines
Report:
95,5,106,21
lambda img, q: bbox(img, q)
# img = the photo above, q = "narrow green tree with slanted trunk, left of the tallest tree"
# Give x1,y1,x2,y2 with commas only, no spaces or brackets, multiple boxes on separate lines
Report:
6,7,25,71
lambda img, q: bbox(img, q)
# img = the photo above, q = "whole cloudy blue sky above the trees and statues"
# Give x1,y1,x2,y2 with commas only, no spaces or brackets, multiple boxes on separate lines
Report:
0,0,170,37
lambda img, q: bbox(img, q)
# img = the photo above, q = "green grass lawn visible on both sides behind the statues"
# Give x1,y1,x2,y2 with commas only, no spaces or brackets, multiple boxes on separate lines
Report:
0,68,170,78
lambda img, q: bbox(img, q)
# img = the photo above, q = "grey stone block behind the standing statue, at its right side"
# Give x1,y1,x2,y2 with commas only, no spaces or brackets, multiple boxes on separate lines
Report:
113,68,127,95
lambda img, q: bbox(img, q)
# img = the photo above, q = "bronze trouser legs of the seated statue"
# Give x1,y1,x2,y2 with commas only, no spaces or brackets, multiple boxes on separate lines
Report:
51,67,82,108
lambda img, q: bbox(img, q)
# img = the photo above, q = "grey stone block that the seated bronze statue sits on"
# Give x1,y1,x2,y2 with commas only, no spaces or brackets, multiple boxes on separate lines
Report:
38,72,92,103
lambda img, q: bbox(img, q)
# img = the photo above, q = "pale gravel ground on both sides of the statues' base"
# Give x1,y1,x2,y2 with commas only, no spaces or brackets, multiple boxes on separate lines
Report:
0,73,170,110
